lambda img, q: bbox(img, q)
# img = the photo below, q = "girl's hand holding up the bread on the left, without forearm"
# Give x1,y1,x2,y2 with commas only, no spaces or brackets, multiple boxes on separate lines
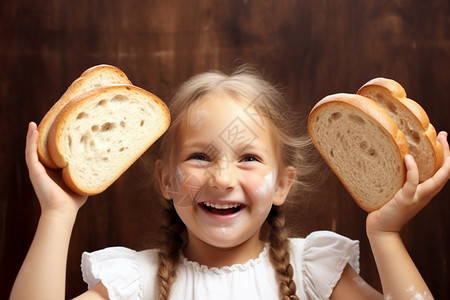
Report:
25,122,87,214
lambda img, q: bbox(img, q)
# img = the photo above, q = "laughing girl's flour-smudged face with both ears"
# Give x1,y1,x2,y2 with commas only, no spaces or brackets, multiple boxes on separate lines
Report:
160,95,292,256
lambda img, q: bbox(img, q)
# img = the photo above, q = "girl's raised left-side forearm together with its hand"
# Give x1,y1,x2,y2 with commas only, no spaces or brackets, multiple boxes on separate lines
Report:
10,123,87,300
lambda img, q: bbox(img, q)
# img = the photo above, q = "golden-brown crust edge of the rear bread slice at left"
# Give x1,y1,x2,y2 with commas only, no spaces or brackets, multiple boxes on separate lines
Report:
37,64,131,169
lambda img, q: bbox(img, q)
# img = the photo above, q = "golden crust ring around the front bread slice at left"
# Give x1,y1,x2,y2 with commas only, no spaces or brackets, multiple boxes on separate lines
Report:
48,85,170,195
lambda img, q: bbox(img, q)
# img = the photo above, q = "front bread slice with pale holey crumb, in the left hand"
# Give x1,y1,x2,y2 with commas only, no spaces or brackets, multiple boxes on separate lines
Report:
48,85,170,195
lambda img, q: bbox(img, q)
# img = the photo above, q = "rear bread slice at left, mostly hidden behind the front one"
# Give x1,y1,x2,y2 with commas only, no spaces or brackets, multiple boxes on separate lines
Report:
37,65,131,169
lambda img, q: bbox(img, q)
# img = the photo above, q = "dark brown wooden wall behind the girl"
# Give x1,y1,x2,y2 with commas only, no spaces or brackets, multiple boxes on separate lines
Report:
0,0,450,299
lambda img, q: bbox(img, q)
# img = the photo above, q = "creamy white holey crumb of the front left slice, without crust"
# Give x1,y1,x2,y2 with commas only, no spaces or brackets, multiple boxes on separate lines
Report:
61,90,166,190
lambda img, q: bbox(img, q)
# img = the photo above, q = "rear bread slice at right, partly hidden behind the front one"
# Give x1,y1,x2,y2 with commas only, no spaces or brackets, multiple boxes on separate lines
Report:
357,77,444,182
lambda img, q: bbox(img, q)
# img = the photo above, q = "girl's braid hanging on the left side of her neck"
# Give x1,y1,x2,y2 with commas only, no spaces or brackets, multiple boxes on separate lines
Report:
157,201,186,300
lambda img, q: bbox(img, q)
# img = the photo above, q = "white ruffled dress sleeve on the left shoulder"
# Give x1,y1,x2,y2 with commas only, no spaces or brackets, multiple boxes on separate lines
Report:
81,247,143,300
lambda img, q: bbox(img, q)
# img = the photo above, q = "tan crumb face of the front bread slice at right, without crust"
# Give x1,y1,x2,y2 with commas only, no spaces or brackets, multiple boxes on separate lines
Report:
310,104,403,209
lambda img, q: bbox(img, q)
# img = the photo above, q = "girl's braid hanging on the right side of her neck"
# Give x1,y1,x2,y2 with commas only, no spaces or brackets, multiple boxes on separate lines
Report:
267,206,299,300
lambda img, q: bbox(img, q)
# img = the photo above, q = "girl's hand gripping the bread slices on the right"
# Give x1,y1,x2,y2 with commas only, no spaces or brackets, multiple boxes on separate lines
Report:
366,132,450,234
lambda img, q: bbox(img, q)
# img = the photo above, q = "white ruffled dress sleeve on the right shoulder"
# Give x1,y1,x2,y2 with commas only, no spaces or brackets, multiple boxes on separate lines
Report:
291,231,359,299
